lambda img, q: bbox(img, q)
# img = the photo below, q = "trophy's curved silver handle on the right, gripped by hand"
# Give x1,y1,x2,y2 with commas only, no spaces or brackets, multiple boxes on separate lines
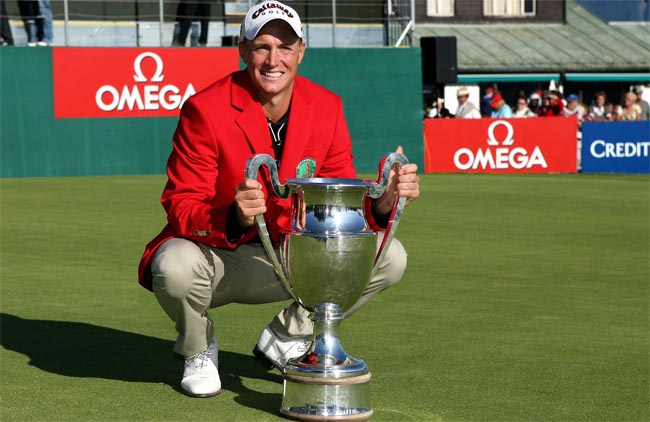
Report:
368,152,409,278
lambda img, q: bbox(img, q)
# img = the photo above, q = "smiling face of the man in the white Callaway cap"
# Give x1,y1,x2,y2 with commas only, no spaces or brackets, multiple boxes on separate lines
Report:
239,20,305,102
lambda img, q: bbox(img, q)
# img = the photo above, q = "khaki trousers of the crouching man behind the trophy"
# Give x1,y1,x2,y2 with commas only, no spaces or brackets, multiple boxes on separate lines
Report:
151,232,407,357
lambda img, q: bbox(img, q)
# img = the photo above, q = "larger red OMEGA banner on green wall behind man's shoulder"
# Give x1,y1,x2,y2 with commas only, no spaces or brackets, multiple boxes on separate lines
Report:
52,47,239,118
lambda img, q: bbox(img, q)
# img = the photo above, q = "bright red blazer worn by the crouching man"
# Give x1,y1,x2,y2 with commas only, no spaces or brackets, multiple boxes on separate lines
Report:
138,71,376,290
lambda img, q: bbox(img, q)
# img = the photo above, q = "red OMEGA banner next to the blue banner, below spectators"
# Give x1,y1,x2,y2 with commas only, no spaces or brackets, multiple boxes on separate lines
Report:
424,117,578,173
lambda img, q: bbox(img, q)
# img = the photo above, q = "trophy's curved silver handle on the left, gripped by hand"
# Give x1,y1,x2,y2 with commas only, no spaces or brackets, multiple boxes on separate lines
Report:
245,154,298,301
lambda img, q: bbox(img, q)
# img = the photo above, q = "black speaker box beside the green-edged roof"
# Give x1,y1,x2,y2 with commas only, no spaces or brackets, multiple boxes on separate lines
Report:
420,37,458,85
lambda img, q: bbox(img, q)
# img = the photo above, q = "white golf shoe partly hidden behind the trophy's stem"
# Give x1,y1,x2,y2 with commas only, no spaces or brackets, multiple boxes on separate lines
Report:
253,327,311,371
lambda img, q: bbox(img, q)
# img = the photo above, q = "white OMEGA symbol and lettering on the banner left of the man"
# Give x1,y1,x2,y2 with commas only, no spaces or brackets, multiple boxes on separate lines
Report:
95,51,196,111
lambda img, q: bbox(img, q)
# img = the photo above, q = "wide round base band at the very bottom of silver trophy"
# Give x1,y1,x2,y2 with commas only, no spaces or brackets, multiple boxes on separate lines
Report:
280,372,373,421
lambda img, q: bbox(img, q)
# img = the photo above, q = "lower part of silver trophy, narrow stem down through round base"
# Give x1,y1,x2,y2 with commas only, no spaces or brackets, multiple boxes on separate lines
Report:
280,303,373,421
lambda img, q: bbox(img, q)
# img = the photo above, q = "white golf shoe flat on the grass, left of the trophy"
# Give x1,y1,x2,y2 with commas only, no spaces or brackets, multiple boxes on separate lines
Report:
181,339,221,397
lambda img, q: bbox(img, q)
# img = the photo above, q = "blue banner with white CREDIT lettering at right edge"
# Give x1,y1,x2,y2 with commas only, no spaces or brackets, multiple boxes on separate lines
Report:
582,120,650,173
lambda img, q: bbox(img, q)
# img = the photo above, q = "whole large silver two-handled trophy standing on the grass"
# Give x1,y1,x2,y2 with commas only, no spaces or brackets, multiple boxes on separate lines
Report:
246,153,408,421
